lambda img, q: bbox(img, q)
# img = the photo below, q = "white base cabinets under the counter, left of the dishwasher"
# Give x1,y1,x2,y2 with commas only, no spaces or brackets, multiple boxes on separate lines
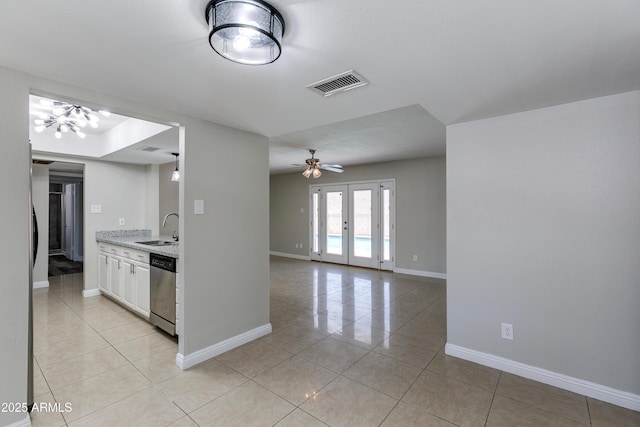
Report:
98,243,151,318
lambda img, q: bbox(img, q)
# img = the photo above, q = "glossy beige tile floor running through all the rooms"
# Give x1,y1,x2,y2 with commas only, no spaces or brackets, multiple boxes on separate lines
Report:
32,257,640,427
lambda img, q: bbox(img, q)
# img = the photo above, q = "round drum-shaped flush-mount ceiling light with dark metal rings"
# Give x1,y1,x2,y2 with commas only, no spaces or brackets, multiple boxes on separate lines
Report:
205,0,284,65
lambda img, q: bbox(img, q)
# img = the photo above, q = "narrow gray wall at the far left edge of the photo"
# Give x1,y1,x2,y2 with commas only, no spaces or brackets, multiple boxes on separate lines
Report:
0,68,31,426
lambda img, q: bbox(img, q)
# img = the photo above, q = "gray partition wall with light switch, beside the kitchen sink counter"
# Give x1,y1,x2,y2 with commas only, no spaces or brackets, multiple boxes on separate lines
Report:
180,119,269,355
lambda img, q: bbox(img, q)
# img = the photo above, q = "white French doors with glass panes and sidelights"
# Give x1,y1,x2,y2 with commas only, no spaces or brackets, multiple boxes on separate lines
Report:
309,181,395,270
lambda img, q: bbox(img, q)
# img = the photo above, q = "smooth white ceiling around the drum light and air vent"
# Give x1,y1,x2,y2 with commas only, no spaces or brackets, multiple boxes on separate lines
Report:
0,0,640,172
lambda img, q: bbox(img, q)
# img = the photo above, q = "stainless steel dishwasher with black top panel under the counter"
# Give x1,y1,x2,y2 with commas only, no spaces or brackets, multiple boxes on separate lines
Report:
149,253,176,335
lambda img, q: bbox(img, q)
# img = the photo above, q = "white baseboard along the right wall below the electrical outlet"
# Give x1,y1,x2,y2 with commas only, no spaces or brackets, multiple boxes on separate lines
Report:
445,344,640,411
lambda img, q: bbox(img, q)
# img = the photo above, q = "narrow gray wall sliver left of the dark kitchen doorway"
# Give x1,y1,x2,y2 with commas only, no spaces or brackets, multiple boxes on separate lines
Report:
31,165,49,285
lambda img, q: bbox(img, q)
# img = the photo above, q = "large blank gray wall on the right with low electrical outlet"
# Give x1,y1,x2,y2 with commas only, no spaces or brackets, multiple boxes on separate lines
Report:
447,92,640,394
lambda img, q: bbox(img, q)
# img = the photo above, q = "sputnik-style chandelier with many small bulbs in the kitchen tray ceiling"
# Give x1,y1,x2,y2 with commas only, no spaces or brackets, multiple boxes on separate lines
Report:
33,99,111,139
